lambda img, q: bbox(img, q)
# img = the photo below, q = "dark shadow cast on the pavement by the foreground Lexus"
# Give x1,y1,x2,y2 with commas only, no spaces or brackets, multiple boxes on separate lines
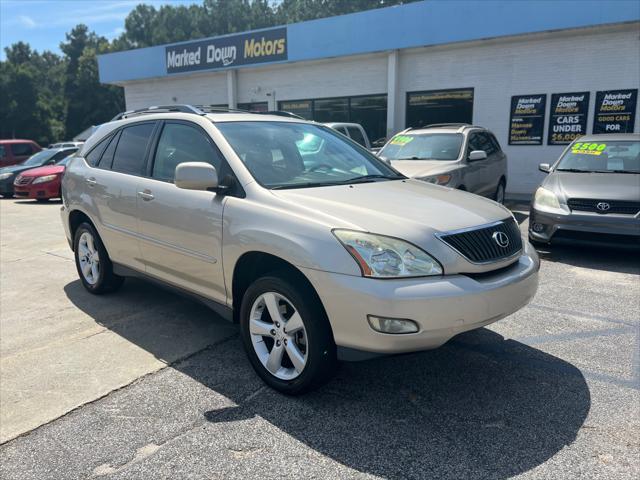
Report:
65,281,591,479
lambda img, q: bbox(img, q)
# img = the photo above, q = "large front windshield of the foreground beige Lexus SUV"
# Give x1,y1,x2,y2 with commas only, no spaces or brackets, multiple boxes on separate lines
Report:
216,122,405,188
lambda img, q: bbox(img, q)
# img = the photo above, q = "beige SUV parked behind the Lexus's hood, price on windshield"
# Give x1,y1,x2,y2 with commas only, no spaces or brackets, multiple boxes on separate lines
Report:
378,123,507,203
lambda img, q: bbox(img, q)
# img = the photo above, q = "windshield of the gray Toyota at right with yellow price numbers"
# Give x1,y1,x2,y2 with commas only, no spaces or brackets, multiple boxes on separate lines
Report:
555,140,640,173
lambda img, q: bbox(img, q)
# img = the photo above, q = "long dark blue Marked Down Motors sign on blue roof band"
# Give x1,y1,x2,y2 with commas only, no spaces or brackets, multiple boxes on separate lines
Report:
165,27,288,73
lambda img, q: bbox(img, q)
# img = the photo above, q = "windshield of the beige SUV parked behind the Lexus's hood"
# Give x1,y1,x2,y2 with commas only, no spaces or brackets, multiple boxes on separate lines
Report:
379,133,463,160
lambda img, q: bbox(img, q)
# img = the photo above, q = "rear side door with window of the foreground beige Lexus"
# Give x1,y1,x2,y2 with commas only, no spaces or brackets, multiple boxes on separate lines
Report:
85,122,157,271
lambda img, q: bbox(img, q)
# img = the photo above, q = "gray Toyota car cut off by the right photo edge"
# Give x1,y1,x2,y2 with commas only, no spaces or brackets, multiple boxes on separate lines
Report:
529,133,640,248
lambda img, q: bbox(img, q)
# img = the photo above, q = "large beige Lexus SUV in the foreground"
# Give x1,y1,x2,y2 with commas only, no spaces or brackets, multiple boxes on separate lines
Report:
61,105,539,394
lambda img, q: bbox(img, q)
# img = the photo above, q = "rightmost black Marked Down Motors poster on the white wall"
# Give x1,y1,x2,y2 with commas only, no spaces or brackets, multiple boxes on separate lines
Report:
593,88,638,133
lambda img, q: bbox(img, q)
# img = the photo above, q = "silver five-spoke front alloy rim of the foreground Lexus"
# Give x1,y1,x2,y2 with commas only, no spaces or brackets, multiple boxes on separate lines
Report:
249,292,308,380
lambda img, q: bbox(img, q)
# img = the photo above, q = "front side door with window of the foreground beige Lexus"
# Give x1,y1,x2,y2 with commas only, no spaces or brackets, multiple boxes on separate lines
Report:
138,121,226,303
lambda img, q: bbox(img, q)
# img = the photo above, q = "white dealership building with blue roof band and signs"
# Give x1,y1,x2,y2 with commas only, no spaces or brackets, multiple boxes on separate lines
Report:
98,0,640,197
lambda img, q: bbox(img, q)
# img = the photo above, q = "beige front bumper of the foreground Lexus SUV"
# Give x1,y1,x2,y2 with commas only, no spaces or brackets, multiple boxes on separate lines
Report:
301,241,540,354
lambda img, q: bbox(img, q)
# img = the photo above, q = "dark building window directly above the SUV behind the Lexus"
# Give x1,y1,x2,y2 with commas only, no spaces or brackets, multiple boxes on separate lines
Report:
406,88,473,128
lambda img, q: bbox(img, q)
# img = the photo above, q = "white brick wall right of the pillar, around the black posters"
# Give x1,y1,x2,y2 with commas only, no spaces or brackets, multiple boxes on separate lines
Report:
398,24,640,195
